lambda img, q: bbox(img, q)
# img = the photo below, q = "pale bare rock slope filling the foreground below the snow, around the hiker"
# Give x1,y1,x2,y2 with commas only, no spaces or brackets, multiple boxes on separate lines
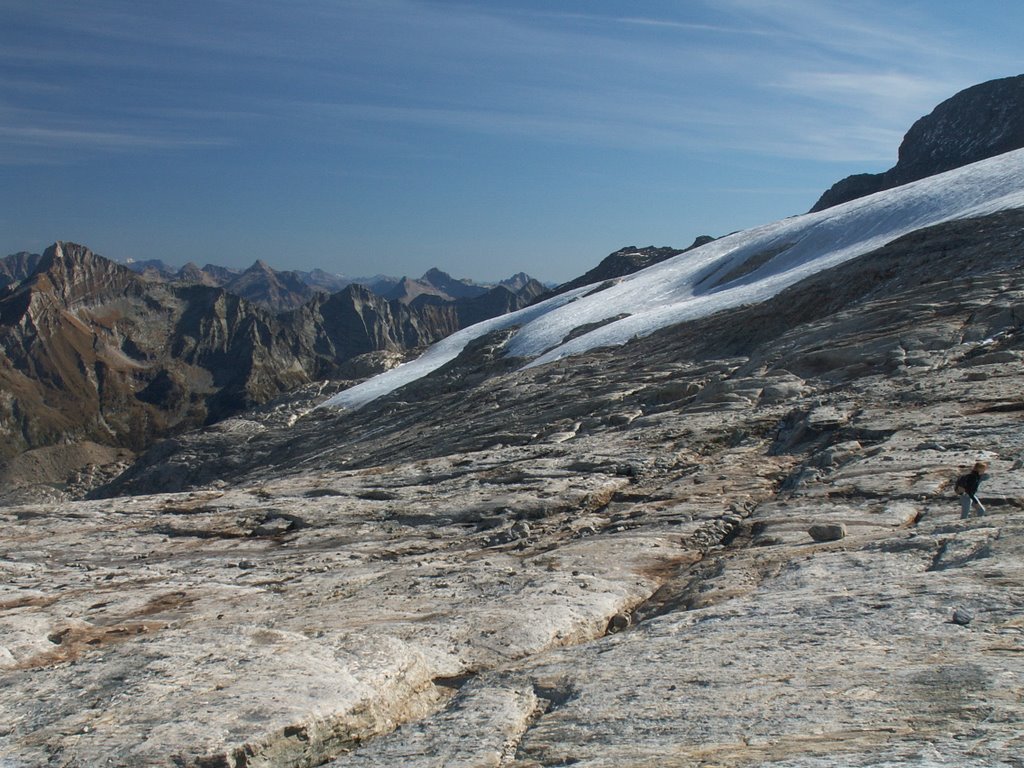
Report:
0,205,1024,768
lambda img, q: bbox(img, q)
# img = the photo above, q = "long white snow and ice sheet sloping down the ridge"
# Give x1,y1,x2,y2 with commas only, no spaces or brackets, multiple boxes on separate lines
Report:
322,150,1024,409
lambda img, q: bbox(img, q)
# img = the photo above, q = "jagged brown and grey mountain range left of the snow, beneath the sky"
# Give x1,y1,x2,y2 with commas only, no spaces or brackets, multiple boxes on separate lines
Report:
0,243,544,468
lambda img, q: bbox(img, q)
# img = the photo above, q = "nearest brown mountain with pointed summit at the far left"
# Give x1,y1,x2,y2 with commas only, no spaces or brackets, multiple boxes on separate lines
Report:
0,243,307,458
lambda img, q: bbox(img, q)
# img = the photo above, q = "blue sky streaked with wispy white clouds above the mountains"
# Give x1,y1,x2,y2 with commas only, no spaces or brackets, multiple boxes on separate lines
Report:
0,0,1024,281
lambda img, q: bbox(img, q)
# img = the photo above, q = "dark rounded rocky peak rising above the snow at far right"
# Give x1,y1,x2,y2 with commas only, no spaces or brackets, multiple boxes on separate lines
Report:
811,75,1024,211
